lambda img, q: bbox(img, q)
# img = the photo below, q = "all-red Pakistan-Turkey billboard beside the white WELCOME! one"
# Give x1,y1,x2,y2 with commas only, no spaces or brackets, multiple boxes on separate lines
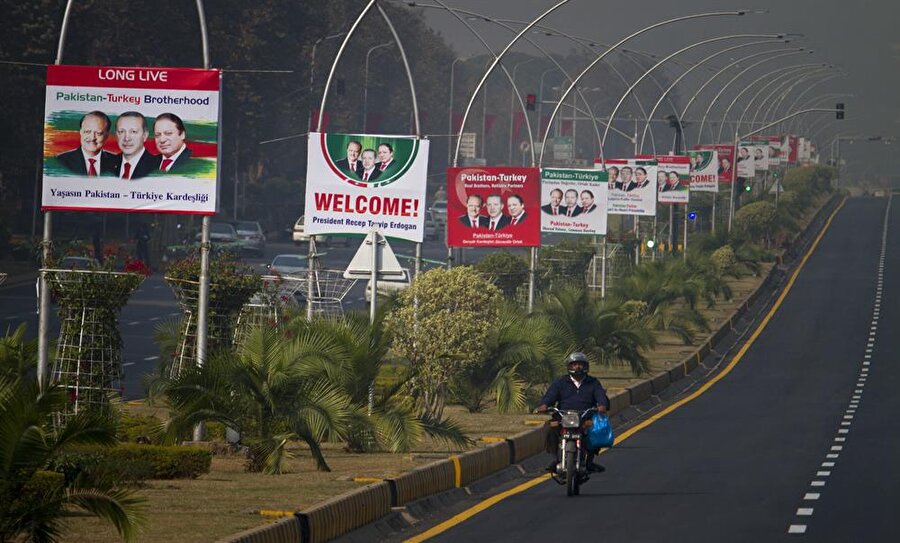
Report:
447,167,541,247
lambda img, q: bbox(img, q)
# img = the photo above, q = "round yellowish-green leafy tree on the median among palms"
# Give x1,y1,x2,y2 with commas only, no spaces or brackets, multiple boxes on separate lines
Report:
386,266,503,421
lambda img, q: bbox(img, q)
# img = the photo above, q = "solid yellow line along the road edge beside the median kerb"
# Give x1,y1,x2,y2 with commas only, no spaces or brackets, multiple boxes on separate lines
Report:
403,198,847,543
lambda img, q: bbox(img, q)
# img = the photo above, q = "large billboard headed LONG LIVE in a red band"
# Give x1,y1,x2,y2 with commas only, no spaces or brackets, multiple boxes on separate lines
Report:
41,65,221,215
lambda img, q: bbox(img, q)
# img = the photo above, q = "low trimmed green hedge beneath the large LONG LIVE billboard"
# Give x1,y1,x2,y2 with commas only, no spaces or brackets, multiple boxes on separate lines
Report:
52,444,212,484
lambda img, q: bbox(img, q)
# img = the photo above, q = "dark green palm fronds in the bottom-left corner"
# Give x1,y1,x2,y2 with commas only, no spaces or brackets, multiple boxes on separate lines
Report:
0,377,142,541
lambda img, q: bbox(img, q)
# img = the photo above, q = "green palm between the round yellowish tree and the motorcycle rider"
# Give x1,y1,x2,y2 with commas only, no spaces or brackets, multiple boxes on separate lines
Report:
450,304,553,413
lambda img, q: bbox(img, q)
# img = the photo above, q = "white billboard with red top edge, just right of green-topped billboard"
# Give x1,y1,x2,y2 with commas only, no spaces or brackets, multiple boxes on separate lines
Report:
594,158,656,217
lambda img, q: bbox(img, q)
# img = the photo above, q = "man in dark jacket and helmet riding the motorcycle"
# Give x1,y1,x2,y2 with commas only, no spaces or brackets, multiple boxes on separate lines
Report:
537,352,609,473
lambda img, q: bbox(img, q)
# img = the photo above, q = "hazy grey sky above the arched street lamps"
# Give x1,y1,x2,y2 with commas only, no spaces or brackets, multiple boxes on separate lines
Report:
412,0,900,173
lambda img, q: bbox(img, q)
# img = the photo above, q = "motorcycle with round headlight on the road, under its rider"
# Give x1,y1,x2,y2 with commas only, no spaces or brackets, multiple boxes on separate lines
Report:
547,407,597,496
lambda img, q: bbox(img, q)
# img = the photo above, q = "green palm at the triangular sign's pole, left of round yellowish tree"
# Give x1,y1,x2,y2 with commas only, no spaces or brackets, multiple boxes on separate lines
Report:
289,310,470,452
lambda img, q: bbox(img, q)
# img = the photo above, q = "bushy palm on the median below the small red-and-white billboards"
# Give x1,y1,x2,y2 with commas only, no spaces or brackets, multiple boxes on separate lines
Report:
615,261,709,345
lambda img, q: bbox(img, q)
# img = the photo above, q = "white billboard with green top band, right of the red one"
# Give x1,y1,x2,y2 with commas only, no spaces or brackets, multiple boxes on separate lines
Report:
541,168,609,235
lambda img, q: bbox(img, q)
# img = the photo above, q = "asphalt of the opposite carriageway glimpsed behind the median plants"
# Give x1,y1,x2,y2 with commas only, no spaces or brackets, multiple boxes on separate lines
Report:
0,234,524,400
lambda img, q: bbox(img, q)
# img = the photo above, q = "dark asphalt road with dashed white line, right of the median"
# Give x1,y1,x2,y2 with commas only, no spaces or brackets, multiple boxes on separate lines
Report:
404,199,900,542
